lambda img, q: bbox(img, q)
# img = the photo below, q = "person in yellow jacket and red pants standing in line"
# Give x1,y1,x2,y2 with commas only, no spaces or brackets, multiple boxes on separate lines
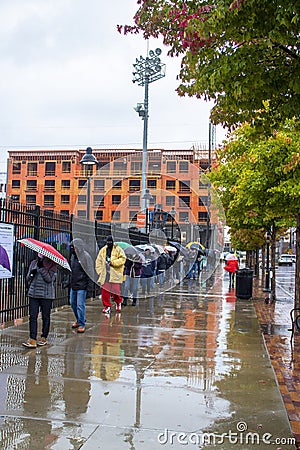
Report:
95,235,126,314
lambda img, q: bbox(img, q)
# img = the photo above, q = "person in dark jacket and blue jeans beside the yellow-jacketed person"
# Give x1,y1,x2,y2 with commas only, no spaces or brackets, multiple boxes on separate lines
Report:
70,238,94,333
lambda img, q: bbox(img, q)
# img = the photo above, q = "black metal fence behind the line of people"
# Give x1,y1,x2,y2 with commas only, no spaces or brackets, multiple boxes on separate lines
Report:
0,199,148,326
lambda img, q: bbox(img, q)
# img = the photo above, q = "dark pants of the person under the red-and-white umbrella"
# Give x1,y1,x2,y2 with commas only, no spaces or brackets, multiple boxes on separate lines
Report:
29,297,52,340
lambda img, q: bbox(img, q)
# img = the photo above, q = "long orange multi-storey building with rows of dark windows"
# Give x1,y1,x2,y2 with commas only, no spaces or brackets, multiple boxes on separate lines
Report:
7,149,218,243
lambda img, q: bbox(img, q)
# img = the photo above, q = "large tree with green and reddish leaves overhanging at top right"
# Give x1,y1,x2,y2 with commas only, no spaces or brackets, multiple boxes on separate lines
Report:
118,0,300,128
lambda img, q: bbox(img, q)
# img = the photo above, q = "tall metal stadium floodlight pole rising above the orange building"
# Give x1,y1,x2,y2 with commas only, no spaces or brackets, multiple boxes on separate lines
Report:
132,48,166,229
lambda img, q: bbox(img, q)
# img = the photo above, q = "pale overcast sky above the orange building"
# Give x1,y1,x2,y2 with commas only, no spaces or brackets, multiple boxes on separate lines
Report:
0,0,225,171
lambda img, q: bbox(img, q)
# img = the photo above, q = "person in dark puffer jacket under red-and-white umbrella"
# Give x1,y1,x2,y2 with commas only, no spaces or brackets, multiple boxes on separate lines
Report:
22,253,57,348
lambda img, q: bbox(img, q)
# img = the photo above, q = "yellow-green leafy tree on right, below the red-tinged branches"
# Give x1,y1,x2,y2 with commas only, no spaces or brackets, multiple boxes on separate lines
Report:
210,121,300,307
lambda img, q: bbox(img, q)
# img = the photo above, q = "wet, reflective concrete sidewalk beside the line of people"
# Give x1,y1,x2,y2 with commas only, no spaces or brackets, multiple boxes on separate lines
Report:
0,270,295,450
